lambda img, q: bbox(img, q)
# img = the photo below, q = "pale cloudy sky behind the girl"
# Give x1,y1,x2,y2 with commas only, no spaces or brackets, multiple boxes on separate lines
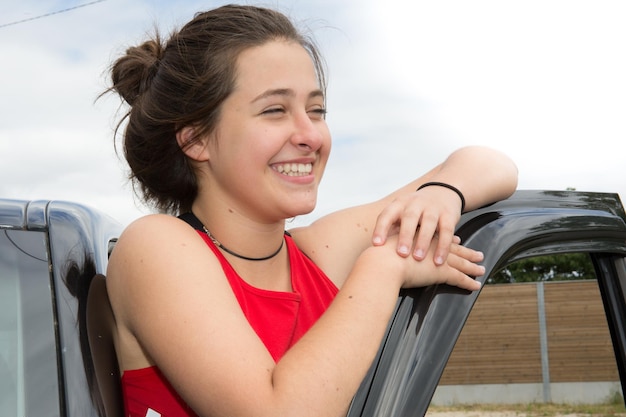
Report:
0,0,626,225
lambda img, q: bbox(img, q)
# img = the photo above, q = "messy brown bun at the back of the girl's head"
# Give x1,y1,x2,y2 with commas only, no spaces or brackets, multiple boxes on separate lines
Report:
111,35,165,106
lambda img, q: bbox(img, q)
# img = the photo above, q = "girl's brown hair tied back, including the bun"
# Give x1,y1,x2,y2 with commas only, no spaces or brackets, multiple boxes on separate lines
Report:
107,5,326,214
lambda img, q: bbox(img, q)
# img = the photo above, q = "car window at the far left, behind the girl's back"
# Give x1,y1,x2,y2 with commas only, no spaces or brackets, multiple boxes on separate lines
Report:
0,229,59,417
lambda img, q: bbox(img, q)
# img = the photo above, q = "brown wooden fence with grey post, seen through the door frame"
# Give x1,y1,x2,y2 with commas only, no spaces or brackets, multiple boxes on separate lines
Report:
433,280,620,404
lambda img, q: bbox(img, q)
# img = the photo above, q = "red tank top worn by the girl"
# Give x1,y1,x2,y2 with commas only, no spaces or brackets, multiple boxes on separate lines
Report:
122,231,338,417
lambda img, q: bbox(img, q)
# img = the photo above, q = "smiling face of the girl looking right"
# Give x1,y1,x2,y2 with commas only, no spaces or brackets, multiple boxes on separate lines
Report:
208,41,330,221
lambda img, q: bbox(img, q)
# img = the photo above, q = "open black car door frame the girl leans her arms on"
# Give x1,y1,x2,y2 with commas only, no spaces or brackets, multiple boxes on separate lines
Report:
348,191,626,417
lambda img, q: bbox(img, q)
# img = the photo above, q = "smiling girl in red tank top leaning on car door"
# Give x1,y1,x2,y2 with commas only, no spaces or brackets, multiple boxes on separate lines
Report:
107,6,517,417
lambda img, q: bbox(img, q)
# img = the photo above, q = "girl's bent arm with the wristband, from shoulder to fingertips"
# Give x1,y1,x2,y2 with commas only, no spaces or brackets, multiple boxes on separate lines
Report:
292,146,517,285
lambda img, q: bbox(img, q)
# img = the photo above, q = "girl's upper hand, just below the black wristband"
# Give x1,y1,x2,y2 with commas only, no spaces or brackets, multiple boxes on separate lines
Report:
372,186,461,265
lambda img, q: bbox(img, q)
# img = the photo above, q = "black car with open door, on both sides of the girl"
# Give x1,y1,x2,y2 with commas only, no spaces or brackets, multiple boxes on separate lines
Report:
0,191,626,417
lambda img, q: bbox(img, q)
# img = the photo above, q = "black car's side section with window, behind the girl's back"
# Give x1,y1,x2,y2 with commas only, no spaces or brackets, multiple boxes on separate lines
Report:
0,199,121,417
